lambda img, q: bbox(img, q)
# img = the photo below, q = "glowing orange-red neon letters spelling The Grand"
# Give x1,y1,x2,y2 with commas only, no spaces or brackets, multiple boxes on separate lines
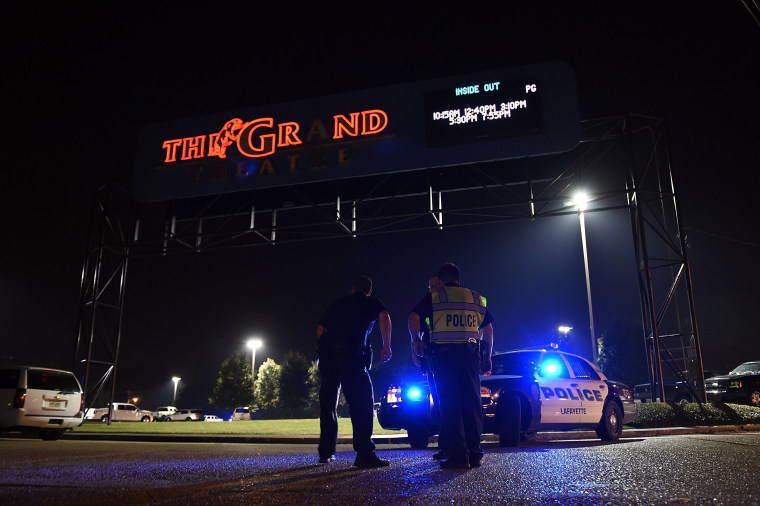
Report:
162,109,388,163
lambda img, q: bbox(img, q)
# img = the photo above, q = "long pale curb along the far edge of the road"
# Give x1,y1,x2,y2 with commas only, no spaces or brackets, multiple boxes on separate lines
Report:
61,424,760,444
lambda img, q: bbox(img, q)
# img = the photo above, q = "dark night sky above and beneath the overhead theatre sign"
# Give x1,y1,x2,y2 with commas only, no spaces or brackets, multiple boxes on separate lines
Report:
0,0,760,408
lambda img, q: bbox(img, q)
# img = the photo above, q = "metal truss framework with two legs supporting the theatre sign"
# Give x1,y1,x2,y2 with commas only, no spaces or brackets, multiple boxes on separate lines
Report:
74,115,704,408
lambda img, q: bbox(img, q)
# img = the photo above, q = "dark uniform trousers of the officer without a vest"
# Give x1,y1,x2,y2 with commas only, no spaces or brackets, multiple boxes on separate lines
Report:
319,353,375,457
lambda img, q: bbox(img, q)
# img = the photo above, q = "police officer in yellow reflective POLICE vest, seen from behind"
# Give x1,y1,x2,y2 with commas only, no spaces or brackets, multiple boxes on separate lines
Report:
409,263,493,469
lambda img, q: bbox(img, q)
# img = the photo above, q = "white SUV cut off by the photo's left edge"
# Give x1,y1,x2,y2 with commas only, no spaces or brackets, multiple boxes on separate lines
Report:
0,366,84,440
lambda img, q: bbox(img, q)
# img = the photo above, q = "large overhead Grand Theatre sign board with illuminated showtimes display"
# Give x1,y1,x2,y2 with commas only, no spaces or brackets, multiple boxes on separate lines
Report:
133,62,580,201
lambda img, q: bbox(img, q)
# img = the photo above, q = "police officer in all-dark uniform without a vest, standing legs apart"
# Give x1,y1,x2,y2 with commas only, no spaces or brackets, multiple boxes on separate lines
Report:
317,276,392,468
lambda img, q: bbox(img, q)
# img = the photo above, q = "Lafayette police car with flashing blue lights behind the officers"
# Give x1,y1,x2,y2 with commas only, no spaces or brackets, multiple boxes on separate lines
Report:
378,349,637,448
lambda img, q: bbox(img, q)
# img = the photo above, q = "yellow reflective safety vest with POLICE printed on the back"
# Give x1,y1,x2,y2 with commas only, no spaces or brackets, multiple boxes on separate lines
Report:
430,286,486,343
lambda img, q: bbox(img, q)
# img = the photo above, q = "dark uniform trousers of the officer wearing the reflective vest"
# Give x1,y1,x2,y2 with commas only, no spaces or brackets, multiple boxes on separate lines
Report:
432,343,483,462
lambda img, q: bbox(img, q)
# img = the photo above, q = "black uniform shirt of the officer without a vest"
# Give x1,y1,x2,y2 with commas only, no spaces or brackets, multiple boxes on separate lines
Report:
319,292,387,346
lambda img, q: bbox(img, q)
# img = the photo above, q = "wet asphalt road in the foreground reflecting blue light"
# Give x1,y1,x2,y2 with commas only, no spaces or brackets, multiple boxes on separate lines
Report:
0,433,760,505
